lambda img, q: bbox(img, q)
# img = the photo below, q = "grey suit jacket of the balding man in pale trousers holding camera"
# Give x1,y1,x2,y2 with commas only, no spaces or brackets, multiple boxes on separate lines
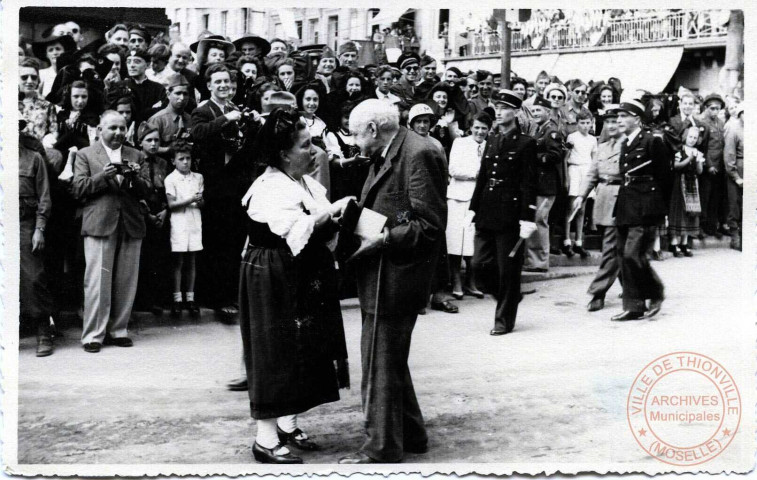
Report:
71,141,152,238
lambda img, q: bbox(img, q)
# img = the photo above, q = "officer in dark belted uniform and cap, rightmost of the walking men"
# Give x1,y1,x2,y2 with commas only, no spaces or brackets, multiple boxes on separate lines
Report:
612,100,672,321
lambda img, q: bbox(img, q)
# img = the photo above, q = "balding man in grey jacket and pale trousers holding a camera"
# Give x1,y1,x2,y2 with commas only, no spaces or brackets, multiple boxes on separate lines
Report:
71,110,151,353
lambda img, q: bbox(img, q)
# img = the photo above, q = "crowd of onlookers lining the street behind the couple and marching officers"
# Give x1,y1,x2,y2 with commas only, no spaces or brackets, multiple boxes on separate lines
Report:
19,22,743,348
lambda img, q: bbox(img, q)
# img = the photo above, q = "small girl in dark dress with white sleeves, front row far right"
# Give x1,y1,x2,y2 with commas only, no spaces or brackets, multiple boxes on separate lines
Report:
668,127,704,257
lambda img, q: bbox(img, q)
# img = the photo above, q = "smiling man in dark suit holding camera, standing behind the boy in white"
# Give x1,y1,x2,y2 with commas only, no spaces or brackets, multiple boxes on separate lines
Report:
190,64,246,322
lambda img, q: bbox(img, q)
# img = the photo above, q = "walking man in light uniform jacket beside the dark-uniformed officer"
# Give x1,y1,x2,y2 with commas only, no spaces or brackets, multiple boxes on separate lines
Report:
573,105,623,312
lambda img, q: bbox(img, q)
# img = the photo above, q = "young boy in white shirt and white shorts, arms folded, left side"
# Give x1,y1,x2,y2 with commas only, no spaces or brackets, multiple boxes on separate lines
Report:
165,140,204,317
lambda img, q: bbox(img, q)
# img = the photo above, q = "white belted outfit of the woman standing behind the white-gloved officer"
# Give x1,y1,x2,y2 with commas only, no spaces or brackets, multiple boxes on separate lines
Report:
446,135,486,257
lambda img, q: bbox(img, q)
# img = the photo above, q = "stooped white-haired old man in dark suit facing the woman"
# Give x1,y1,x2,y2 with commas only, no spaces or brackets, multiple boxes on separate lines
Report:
339,99,447,464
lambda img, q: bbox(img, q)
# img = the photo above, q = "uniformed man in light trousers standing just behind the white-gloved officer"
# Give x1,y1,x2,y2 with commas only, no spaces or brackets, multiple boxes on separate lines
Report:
524,95,565,272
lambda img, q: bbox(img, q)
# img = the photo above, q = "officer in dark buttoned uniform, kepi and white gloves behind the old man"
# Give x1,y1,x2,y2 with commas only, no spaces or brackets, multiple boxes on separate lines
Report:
470,90,536,335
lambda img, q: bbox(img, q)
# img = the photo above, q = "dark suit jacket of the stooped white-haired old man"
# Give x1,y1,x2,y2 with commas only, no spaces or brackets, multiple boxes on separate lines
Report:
356,127,447,315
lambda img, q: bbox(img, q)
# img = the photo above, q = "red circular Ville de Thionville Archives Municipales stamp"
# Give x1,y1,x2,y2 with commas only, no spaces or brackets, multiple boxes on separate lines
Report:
626,352,741,466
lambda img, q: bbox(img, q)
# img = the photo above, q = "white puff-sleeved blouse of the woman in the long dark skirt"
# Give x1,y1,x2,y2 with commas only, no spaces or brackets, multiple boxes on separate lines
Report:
245,178,315,256
